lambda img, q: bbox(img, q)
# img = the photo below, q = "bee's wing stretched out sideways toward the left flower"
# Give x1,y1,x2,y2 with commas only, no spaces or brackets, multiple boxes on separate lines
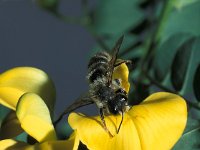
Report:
54,93,94,126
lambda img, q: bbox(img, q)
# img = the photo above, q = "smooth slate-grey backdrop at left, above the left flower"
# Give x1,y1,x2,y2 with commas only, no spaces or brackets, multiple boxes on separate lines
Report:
0,0,95,116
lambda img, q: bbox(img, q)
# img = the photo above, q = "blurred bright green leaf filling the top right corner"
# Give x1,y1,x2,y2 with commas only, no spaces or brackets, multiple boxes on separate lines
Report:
160,0,200,41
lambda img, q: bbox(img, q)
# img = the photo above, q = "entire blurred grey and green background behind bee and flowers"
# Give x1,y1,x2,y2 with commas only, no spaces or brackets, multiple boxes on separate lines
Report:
0,0,200,150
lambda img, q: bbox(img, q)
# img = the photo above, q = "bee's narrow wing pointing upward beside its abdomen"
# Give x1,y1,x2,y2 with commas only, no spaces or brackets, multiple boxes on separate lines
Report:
108,36,124,85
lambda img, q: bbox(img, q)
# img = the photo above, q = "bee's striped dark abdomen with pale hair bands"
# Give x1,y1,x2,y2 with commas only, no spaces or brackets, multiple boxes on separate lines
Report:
87,52,111,83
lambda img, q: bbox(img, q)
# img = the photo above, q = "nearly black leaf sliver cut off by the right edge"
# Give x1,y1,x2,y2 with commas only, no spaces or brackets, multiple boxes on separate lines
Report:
193,64,200,101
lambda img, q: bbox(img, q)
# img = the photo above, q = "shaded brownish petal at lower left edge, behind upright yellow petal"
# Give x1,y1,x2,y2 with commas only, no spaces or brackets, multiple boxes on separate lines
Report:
0,111,24,139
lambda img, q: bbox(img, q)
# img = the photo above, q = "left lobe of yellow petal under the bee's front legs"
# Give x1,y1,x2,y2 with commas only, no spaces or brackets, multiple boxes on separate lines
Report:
68,113,141,150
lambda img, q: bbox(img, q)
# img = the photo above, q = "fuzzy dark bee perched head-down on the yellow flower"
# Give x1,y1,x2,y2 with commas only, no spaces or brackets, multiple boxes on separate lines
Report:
54,36,130,136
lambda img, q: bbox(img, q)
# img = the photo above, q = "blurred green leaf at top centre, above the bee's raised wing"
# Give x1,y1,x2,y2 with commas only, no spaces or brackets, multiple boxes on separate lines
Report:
93,0,144,35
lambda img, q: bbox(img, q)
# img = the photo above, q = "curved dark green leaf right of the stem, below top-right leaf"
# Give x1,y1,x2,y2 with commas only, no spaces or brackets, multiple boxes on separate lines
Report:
153,33,191,82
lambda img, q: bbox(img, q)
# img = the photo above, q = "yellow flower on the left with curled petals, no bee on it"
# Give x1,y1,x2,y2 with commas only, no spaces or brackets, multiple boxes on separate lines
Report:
0,67,79,150
